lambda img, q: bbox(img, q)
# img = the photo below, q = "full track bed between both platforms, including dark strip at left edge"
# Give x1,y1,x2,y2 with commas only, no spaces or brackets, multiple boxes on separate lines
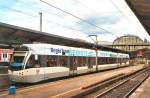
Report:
71,68,150,98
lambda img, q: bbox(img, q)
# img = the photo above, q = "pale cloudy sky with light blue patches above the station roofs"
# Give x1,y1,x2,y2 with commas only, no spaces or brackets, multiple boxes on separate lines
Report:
0,0,150,42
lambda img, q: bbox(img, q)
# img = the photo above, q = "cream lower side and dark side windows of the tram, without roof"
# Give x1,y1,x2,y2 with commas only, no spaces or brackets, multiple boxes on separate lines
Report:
9,55,129,83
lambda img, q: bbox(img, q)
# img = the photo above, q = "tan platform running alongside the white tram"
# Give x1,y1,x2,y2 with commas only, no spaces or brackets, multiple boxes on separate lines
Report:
0,65,145,98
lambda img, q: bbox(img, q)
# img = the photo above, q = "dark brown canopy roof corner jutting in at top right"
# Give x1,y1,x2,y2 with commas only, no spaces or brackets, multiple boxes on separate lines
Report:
126,0,150,35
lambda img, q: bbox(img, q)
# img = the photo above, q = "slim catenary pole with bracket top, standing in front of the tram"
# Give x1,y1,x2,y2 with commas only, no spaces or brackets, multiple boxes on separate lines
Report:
89,35,98,71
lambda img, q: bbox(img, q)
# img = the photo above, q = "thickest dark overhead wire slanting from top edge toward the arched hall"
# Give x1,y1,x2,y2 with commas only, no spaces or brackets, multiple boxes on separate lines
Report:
40,0,117,36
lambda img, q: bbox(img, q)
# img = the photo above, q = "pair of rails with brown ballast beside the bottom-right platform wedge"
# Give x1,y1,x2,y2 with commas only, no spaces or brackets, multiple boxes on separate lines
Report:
95,70,149,98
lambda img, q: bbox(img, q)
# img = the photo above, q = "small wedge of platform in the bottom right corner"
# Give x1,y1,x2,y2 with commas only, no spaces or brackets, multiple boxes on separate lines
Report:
129,73,150,98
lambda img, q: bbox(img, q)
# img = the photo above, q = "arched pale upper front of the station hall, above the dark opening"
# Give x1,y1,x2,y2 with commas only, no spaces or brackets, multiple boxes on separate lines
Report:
109,35,150,52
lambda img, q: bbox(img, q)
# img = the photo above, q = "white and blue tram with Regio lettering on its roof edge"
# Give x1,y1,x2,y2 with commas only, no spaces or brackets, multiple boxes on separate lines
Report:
8,44,129,83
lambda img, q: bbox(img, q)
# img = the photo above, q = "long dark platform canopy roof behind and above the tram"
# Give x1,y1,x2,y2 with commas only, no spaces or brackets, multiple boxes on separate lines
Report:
0,22,126,53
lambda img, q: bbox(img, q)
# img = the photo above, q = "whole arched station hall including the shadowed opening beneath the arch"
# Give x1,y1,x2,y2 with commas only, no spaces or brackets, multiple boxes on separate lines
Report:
108,35,150,65
